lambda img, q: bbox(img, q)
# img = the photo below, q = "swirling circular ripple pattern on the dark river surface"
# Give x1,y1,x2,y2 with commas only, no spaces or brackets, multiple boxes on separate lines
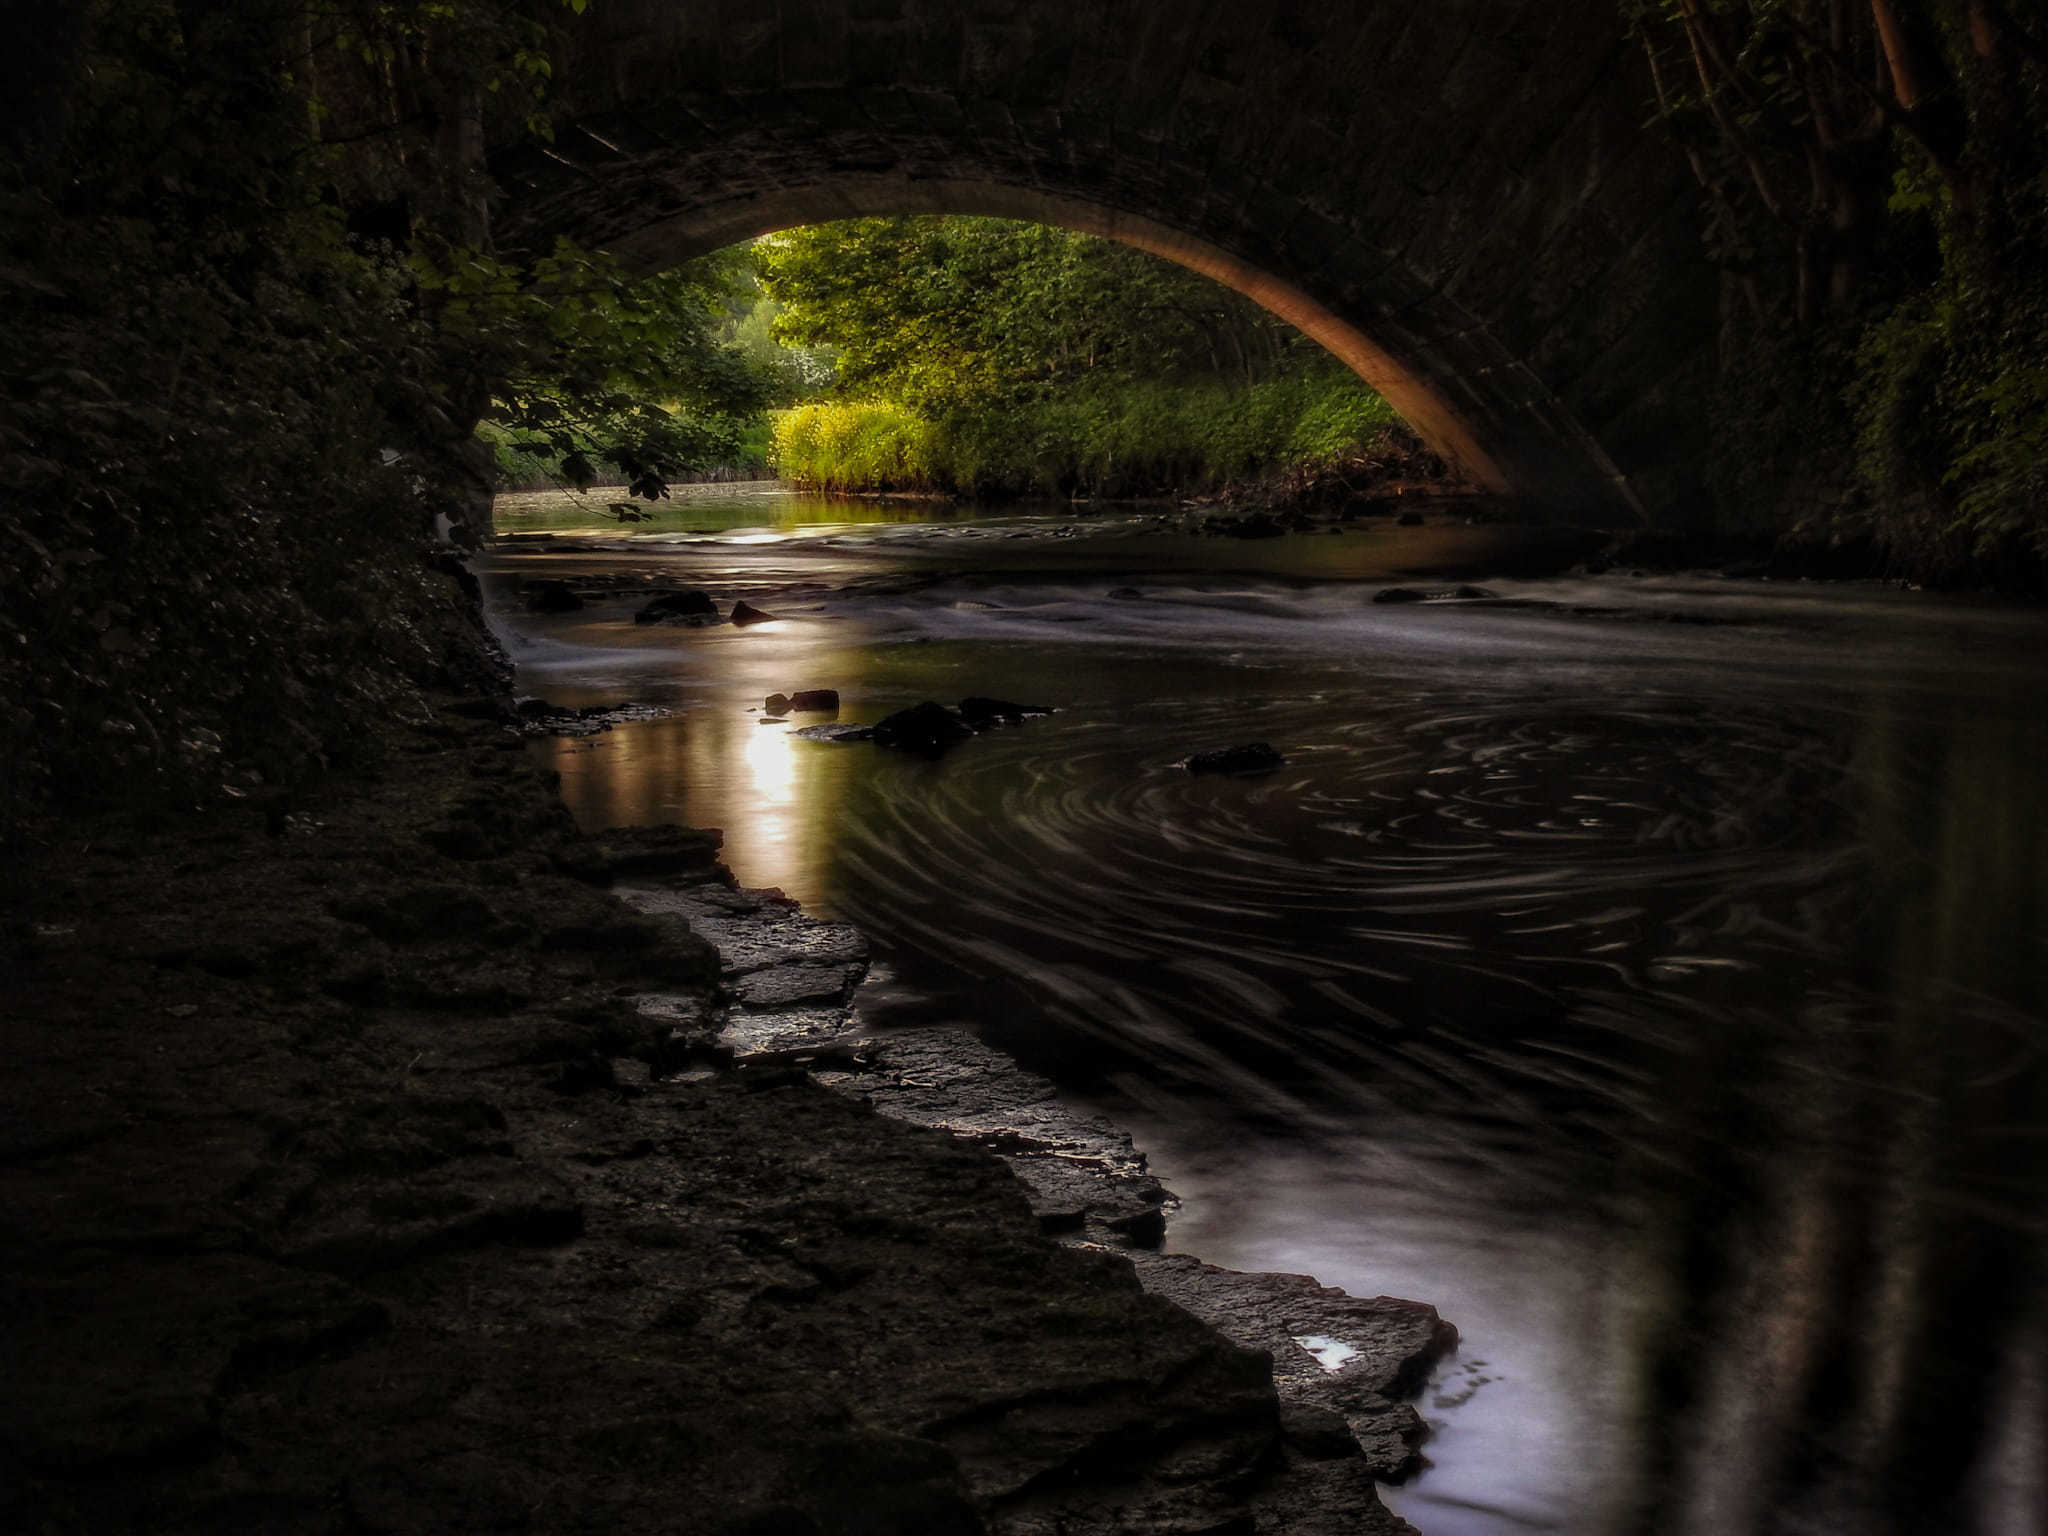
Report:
838,688,1851,1163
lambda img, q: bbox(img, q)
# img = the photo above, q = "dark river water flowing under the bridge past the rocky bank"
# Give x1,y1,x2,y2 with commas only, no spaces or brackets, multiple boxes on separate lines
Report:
481,492,2048,1536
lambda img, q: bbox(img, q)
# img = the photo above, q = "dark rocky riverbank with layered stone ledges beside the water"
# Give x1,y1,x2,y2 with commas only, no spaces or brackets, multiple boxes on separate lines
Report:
0,698,1454,1536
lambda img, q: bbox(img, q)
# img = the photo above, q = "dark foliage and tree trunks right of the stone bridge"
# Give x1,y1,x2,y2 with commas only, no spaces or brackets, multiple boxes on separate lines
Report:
1622,0,2048,582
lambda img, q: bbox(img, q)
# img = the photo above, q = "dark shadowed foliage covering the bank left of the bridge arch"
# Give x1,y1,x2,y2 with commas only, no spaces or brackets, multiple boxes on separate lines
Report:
0,0,647,844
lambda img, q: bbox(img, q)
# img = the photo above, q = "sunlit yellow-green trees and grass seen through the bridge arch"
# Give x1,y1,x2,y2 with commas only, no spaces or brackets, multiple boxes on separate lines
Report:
758,217,1393,496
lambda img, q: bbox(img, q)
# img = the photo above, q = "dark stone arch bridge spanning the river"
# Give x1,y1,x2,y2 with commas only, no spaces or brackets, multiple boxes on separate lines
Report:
492,0,1718,522
